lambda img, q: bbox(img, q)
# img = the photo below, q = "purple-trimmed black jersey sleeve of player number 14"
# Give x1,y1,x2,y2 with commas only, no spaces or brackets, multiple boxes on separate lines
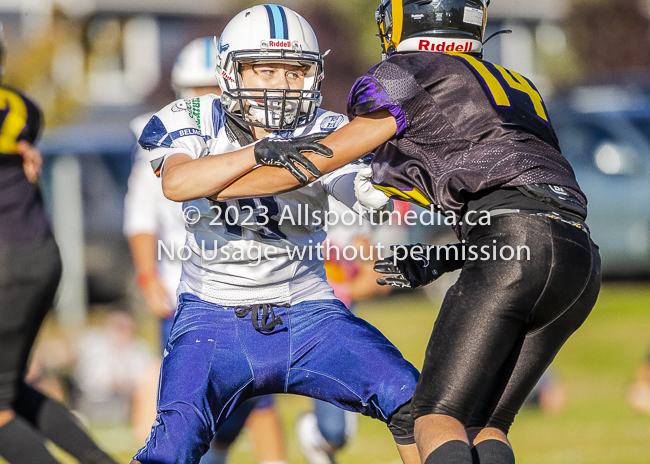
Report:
347,61,417,136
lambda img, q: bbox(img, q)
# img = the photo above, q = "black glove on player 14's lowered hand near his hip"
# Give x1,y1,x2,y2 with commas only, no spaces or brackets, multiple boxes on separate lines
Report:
374,243,464,288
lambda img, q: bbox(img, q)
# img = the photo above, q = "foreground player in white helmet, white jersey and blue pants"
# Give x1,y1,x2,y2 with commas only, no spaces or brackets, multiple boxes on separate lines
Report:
133,5,420,464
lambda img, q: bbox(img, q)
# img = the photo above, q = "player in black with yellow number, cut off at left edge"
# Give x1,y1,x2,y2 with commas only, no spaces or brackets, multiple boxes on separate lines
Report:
0,20,116,464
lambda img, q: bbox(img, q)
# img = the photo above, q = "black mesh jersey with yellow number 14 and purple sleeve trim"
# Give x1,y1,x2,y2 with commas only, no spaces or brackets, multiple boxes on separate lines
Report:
348,52,586,222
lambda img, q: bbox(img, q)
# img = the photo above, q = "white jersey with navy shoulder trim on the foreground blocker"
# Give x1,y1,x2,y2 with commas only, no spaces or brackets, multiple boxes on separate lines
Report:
139,95,359,306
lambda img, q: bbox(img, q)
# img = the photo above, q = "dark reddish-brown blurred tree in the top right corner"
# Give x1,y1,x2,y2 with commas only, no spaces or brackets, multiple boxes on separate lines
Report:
566,0,650,76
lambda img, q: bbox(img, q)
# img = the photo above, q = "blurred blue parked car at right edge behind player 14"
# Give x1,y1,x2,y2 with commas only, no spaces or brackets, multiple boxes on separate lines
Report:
547,84,650,277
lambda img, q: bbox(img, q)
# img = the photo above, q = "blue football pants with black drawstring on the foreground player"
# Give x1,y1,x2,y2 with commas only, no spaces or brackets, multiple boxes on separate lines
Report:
135,293,419,464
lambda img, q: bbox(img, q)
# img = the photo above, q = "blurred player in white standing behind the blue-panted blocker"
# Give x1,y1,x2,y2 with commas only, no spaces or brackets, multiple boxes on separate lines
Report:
124,37,286,464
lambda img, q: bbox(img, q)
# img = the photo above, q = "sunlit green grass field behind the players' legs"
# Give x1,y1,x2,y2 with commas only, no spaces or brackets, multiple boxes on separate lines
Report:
41,283,650,464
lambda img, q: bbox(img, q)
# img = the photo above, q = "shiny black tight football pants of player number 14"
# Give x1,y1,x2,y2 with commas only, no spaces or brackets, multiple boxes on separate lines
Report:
411,213,601,433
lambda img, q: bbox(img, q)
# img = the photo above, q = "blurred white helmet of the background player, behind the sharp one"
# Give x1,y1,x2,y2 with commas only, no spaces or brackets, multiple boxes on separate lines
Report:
172,37,218,98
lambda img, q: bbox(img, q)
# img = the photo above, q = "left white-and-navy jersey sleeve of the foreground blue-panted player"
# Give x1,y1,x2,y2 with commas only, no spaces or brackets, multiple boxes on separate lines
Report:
138,100,208,176
